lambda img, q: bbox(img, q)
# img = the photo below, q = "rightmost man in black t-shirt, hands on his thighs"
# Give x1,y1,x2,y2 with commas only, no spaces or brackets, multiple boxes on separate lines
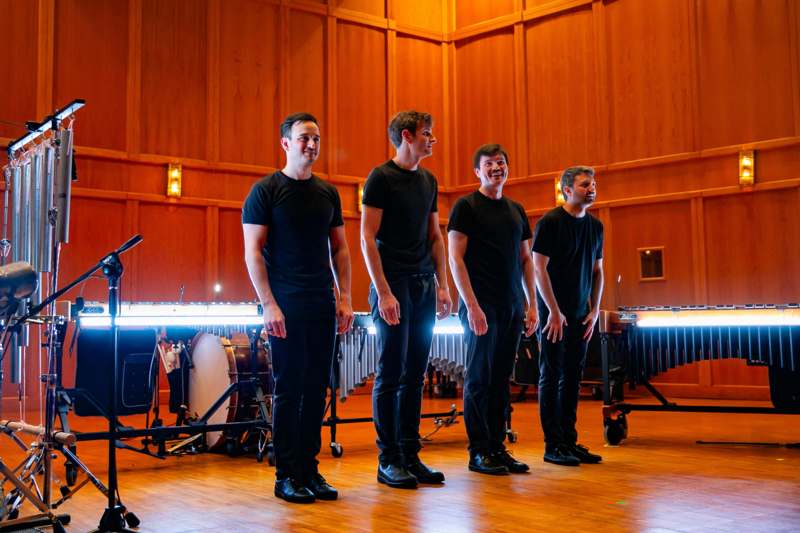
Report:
533,166,603,466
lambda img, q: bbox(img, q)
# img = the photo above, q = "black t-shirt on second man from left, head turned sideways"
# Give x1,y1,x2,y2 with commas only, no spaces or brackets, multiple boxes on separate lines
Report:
363,160,438,280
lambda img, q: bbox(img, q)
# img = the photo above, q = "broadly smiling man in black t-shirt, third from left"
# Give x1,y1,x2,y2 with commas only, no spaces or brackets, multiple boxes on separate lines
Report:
447,144,538,474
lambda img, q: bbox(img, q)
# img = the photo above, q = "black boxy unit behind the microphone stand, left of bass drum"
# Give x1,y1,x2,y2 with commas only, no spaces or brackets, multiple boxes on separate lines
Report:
75,328,158,416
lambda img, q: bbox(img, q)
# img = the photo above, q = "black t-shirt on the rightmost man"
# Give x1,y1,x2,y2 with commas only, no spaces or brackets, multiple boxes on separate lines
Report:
533,207,603,321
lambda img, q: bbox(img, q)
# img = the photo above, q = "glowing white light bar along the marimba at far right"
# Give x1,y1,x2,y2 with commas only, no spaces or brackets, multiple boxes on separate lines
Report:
636,309,800,328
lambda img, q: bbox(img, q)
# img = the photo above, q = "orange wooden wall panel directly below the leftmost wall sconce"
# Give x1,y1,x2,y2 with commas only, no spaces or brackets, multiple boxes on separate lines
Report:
135,203,208,302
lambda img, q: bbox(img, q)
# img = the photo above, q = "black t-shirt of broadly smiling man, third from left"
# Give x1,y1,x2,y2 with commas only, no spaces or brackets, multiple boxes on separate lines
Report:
447,191,531,308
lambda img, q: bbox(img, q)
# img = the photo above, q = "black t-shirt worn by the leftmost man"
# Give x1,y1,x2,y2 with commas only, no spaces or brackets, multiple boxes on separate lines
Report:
242,171,344,312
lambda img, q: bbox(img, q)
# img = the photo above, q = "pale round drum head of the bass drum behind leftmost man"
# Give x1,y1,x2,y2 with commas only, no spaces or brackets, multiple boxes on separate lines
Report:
189,333,232,449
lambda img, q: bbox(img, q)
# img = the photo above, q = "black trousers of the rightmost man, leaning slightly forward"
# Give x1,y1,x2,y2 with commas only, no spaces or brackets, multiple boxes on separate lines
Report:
539,317,587,448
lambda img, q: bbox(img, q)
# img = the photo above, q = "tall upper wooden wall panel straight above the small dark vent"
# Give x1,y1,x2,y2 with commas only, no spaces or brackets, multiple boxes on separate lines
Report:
603,0,694,161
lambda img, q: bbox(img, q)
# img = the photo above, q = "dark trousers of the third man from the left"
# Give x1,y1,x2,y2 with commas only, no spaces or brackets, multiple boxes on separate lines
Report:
458,306,523,452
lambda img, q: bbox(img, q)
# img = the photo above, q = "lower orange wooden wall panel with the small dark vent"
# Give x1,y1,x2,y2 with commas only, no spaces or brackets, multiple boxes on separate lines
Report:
605,202,695,306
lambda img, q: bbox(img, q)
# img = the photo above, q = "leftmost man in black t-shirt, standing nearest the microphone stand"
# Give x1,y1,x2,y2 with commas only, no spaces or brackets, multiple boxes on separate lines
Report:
242,113,353,503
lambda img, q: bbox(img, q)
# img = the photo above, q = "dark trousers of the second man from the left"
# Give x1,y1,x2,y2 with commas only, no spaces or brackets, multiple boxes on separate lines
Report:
369,275,436,463
